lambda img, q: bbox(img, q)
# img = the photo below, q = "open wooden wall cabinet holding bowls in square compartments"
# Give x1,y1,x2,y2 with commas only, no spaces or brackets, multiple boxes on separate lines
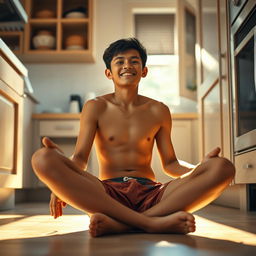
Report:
21,0,93,62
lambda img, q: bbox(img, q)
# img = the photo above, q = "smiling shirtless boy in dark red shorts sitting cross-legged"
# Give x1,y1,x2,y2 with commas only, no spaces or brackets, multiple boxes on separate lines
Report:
32,38,235,237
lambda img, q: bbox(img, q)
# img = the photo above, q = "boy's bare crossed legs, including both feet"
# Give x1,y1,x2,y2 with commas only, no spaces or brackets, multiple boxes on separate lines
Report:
32,141,234,236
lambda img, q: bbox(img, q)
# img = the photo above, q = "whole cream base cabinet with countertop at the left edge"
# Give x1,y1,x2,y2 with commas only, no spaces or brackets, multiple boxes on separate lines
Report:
0,39,27,209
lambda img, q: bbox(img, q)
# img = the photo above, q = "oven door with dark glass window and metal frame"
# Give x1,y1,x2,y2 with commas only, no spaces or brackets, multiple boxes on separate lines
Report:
233,22,256,152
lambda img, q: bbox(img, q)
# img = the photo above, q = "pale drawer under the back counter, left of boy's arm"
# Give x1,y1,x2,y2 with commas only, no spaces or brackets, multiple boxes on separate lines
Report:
39,120,80,137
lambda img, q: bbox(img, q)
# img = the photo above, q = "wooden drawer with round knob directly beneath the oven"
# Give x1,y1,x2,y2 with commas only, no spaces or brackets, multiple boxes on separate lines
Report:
235,150,256,184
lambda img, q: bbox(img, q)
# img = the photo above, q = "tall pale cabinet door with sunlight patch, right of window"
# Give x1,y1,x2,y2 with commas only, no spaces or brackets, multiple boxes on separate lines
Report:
198,0,223,157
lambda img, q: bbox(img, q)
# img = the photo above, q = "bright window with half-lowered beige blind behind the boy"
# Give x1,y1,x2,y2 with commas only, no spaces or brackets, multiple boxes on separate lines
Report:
134,13,180,105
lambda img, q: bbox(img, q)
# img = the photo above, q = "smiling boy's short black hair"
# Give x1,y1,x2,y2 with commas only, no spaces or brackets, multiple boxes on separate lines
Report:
103,38,147,69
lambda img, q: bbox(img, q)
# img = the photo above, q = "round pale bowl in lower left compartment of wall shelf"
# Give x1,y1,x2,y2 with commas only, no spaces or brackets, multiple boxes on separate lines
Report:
32,30,55,50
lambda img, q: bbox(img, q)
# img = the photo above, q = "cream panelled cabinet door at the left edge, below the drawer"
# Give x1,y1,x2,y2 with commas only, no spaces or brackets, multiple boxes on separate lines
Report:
0,80,23,188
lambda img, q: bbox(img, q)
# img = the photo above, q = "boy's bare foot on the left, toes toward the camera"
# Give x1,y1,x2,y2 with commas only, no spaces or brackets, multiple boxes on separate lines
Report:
89,213,131,237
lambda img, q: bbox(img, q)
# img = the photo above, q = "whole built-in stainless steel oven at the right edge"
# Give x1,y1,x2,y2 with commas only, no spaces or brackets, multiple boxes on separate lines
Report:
231,0,256,154
